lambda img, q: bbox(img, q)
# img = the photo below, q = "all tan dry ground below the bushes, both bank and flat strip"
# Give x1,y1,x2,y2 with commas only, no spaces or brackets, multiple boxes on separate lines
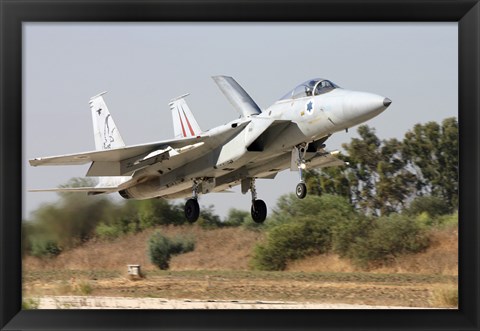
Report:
23,226,458,308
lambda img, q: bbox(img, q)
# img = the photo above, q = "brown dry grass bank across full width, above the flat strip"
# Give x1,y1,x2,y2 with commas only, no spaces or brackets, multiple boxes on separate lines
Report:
24,226,458,277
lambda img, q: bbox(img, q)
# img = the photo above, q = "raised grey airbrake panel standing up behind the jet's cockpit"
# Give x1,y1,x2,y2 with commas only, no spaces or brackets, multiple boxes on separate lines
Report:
212,76,262,117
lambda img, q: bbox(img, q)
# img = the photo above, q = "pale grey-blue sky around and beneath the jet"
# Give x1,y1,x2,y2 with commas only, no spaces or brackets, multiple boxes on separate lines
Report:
22,22,458,219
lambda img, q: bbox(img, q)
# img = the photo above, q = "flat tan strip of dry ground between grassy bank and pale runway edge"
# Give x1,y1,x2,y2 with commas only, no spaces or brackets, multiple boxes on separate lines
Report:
24,271,457,308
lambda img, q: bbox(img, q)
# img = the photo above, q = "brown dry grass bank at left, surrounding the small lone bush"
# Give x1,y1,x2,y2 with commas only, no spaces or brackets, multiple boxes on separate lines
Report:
24,226,261,271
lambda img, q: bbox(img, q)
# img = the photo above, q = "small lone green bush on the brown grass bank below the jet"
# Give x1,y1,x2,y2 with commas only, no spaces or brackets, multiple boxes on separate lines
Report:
148,231,195,270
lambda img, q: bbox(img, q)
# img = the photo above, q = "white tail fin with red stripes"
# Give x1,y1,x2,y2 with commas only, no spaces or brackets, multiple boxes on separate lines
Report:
168,94,202,138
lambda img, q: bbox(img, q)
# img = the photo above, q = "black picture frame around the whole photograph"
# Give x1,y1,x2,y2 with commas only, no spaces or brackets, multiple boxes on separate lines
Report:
0,0,480,330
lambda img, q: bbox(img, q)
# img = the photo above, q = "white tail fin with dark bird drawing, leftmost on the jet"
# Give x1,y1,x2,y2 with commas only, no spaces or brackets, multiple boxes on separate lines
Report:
90,92,125,151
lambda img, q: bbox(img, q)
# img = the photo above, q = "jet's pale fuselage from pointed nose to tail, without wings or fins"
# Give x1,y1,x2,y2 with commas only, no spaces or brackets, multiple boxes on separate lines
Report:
119,88,390,199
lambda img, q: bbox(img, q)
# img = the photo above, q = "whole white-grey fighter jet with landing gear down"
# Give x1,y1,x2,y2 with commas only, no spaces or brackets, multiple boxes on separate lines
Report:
29,76,392,223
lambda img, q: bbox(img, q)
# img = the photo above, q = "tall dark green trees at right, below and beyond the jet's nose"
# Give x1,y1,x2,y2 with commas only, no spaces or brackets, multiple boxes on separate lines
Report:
306,117,458,216
